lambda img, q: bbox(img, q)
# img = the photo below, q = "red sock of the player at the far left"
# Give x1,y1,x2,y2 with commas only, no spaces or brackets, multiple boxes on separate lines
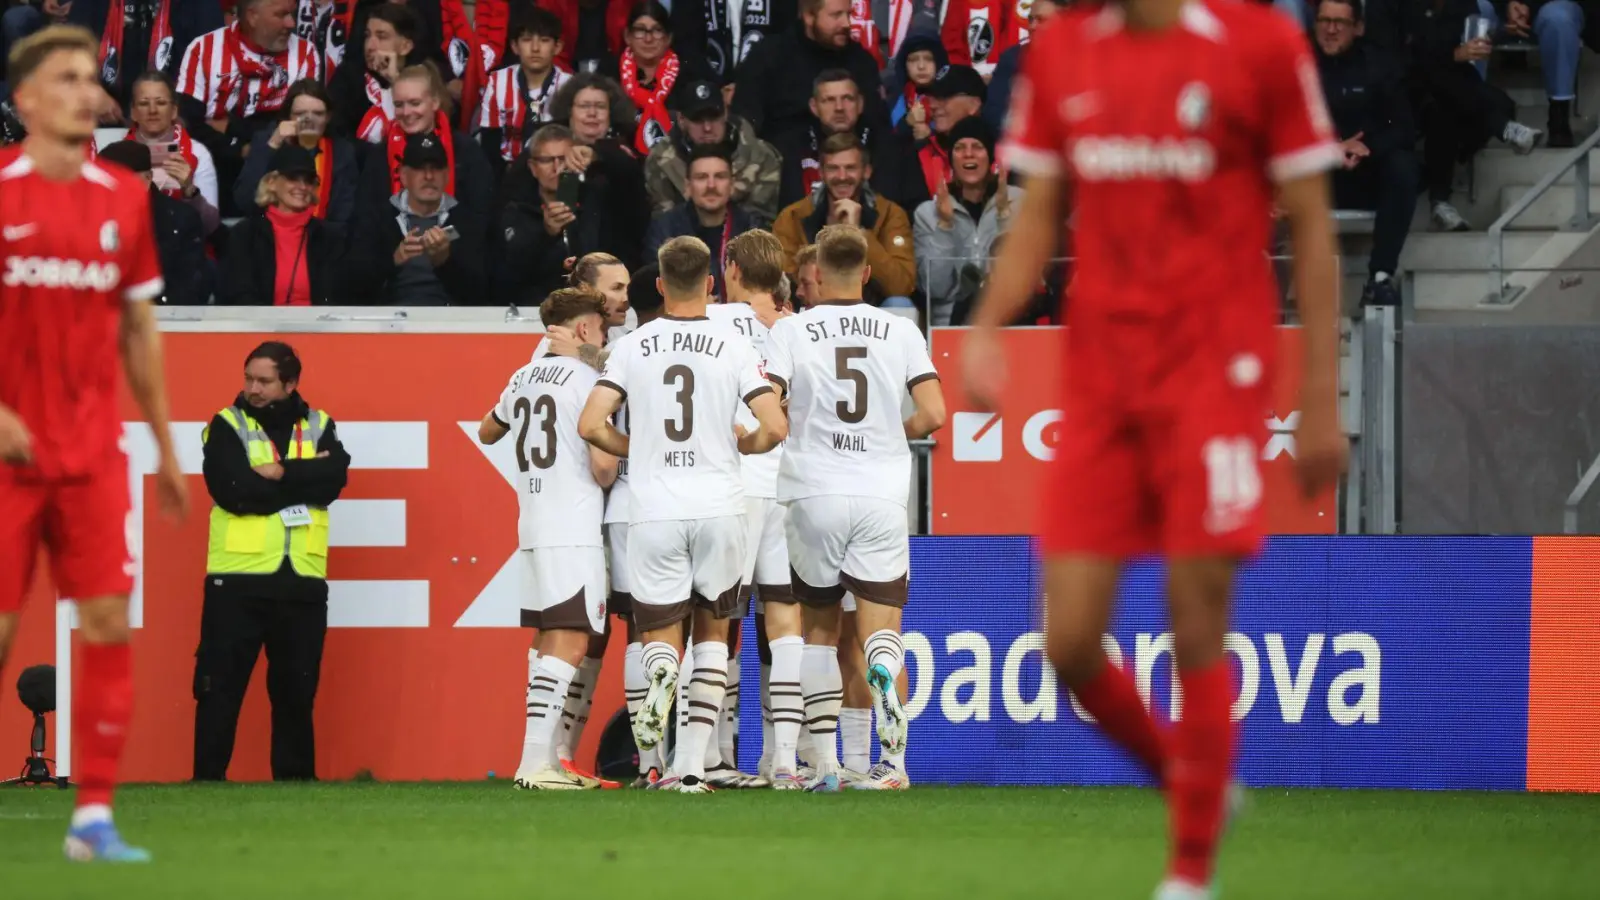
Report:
72,642,133,806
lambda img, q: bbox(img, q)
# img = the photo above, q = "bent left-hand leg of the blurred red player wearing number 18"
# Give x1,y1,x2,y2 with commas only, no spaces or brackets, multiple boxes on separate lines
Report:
1045,556,1166,783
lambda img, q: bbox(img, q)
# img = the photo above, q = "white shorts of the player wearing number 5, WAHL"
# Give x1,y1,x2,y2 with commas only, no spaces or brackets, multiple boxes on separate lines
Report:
786,495,910,607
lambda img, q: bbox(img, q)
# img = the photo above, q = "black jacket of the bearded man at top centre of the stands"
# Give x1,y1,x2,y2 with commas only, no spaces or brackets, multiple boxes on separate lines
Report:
733,32,890,151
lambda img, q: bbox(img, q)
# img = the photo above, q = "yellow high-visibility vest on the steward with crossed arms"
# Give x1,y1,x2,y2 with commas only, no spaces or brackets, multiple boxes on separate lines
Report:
200,407,328,578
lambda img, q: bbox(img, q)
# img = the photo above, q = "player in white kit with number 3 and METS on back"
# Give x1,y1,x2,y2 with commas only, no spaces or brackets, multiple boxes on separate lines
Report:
579,237,789,793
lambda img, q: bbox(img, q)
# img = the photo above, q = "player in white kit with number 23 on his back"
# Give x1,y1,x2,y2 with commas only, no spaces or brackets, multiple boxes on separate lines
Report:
478,288,618,791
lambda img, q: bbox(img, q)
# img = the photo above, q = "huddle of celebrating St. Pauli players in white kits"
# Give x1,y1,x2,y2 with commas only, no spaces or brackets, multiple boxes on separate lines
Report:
478,226,944,793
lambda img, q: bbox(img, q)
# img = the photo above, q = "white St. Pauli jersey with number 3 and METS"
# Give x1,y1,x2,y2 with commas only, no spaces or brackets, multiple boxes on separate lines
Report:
600,315,771,525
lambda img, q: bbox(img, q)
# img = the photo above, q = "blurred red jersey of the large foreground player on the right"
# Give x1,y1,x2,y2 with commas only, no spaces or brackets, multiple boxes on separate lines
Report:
1000,0,1342,329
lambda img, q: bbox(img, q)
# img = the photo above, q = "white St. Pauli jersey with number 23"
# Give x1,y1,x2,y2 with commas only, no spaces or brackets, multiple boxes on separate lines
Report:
494,356,605,549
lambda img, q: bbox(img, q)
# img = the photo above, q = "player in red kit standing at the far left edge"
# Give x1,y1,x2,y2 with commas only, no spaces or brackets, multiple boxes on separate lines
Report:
0,26,186,862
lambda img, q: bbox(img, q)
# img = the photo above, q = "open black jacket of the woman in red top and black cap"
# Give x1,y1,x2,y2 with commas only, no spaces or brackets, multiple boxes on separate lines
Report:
216,210,348,306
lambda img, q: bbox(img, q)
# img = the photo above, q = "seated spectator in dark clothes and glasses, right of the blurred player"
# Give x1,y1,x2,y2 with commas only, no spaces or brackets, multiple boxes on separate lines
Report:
1317,0,1419,306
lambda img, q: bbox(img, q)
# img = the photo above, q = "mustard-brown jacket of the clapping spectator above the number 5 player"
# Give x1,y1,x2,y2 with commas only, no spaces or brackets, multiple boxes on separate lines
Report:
773,184,917,306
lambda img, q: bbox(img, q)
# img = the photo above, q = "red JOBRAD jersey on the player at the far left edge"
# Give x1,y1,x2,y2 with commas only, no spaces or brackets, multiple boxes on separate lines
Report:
0,147,162,479
